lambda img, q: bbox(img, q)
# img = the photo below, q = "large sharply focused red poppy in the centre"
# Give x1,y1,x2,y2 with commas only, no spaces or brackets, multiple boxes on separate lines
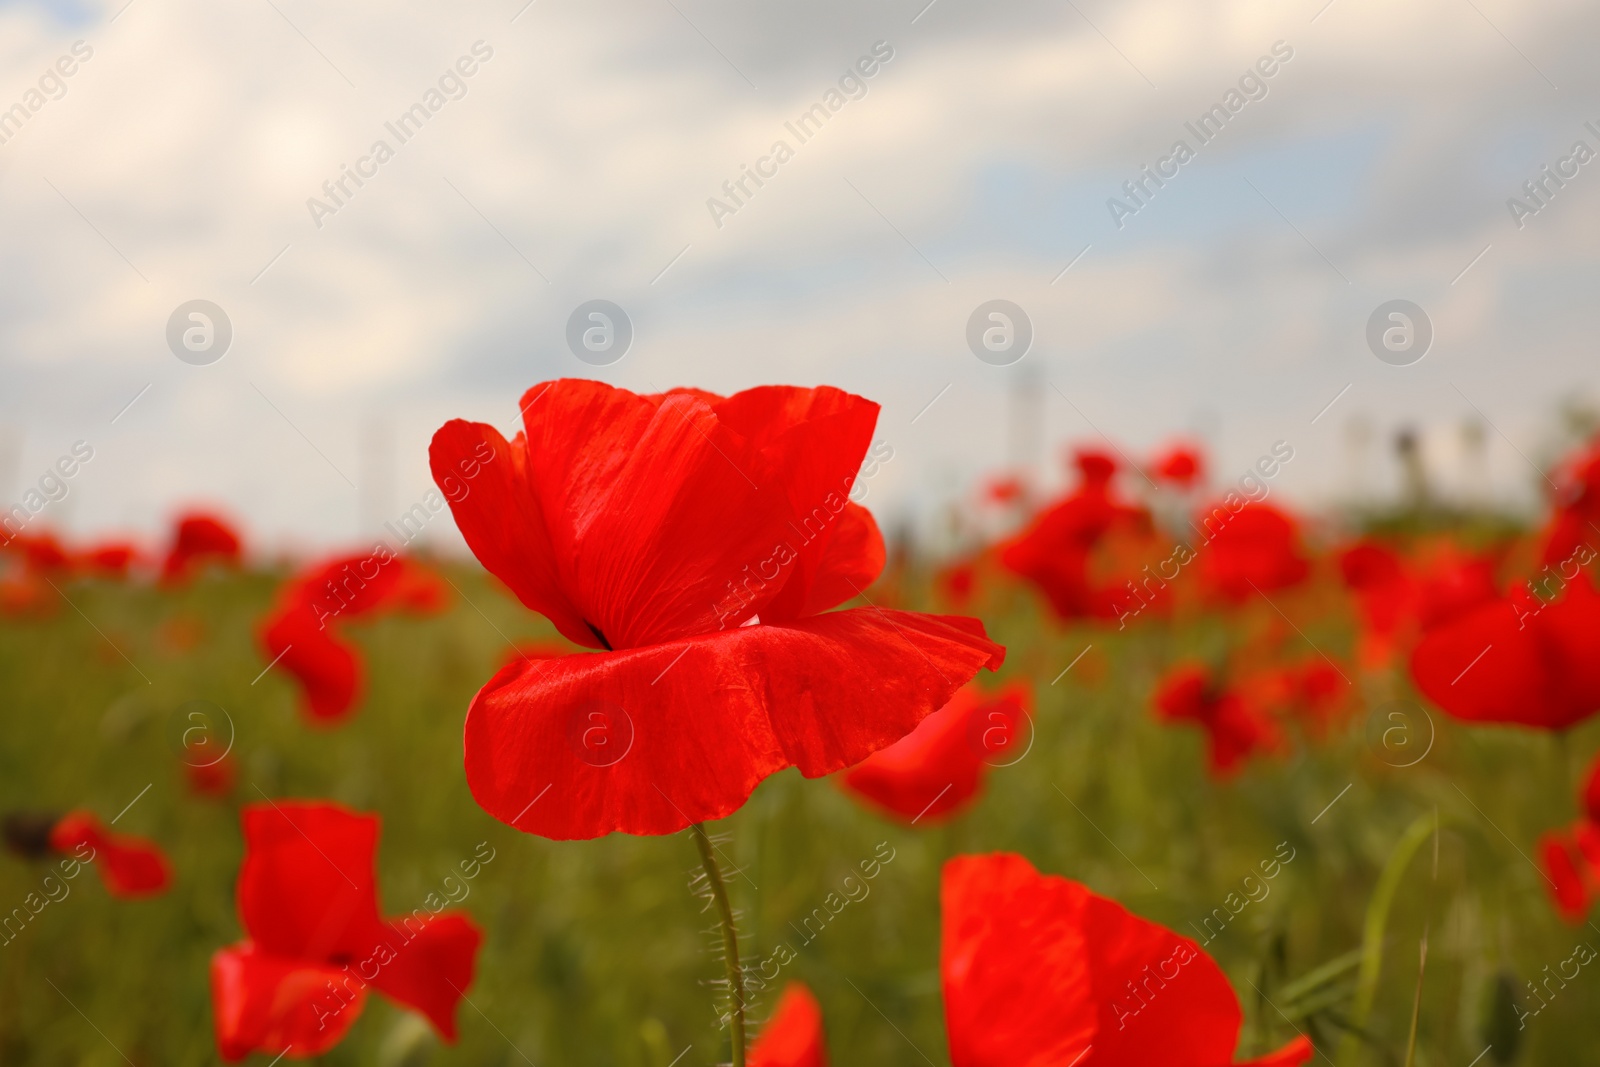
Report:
430,379,1005,838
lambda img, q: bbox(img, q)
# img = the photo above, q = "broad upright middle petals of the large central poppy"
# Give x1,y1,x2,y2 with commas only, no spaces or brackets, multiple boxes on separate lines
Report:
523,381,877,648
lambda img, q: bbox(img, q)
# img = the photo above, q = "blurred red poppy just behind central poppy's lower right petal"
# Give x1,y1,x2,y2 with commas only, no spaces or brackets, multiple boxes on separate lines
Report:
840,683,1034,822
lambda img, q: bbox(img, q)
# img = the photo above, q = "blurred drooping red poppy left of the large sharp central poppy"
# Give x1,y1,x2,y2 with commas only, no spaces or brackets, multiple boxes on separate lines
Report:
261,545,448,725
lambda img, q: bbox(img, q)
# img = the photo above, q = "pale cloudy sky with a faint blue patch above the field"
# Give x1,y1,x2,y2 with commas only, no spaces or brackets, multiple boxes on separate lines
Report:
0,0,1600,545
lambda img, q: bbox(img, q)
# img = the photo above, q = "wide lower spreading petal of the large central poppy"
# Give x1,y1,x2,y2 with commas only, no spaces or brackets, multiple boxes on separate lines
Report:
466,608,1005,838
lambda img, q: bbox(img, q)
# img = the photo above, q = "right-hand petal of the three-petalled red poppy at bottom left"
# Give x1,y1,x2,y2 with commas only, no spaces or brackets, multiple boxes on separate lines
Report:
371,912,483,1043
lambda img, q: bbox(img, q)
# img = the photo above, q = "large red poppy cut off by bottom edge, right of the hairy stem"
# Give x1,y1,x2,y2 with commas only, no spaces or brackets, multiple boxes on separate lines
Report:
939,853,1315,1067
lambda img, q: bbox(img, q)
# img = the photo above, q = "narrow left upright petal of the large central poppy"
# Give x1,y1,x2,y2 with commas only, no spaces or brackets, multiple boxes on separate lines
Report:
427,419,600,648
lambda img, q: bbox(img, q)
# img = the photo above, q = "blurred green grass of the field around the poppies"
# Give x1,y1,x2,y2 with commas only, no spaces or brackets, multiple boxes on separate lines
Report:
0,568,1600,1067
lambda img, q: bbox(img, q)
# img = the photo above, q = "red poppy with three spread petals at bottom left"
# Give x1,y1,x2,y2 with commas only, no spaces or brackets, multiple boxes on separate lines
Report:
211,800,483,1062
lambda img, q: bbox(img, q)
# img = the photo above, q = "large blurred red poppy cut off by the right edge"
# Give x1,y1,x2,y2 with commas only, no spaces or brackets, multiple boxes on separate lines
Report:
1411,577,1600,729
